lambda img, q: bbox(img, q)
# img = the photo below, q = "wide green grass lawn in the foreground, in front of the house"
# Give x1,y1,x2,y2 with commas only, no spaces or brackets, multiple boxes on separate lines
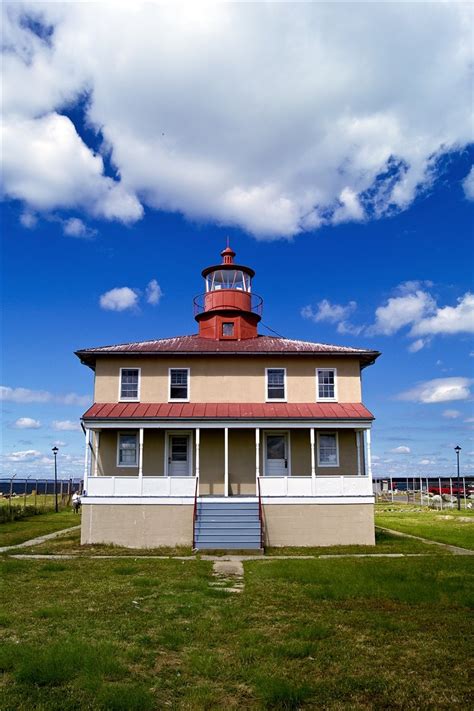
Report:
0,555,474,711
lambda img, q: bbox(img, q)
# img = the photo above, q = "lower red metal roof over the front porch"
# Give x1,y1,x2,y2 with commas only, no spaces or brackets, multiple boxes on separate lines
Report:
83,402,374,420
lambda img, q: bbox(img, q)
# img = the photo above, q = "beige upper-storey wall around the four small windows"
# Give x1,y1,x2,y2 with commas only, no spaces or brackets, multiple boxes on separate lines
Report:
94,356,361,403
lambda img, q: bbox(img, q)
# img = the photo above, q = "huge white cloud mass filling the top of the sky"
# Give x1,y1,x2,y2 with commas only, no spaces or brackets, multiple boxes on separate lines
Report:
3,0,472,238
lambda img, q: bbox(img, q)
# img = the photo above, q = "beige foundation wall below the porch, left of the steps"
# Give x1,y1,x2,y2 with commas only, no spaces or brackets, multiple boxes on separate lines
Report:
81,504,193,548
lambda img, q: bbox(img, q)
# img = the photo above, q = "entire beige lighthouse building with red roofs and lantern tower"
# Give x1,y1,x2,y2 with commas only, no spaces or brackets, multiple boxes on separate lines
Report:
76,247,380,549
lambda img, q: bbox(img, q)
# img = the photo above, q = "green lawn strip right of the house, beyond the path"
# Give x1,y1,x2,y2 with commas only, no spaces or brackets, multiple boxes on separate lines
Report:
375,505,474,550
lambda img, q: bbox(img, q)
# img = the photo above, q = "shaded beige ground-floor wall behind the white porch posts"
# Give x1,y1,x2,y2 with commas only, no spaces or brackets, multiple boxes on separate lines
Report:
93,429,364,482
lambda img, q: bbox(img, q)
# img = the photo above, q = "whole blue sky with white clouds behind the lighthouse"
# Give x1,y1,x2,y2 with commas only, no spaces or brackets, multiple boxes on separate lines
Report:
2,5,474,476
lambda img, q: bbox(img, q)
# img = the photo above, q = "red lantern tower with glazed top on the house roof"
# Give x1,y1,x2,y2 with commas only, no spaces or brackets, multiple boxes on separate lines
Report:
194,245,263,341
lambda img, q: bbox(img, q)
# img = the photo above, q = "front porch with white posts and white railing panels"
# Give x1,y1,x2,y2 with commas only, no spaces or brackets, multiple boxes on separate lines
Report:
84,422,373,504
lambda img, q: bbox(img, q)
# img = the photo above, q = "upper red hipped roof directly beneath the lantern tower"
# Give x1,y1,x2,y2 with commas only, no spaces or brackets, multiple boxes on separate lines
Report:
76,335,380,367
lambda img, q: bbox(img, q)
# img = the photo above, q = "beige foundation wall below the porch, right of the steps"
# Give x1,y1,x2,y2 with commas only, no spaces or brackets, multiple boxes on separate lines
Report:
263,504,375,546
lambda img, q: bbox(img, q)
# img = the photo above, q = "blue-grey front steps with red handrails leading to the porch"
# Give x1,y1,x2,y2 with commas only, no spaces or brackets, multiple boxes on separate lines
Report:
194,498,261,550
